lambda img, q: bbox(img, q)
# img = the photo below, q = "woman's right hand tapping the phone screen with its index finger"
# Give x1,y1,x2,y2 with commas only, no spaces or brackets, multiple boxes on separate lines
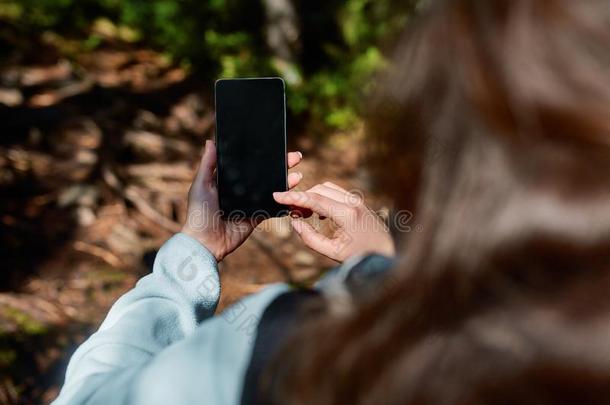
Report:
273,182,395,262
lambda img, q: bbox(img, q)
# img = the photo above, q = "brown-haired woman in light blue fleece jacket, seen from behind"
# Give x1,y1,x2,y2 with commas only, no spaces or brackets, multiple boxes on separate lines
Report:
56,0,610,404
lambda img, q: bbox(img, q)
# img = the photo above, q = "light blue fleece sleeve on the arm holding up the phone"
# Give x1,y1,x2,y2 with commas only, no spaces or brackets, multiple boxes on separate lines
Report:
50,234,220,404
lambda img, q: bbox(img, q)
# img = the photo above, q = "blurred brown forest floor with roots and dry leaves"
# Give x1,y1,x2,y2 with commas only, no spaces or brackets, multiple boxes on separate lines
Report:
0,37,379,404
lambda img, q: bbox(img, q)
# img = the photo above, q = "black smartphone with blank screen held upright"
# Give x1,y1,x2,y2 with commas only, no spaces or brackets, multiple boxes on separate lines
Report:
215,77,289,219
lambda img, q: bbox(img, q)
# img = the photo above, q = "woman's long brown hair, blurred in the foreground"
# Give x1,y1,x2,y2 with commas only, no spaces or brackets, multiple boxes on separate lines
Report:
274,0,610,405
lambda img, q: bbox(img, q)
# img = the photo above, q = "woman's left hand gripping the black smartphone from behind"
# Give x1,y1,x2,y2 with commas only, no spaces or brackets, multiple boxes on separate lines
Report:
182,141,303,261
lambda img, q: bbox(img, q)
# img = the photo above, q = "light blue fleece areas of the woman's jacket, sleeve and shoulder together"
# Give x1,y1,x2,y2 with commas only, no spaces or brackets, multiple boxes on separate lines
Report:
53,234,290,405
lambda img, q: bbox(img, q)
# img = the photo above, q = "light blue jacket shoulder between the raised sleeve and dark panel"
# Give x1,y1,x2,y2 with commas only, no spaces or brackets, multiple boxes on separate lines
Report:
129,284,290,404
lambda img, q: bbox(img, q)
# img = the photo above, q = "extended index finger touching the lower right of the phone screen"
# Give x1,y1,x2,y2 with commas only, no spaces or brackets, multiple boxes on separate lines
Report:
273,191,350,225
